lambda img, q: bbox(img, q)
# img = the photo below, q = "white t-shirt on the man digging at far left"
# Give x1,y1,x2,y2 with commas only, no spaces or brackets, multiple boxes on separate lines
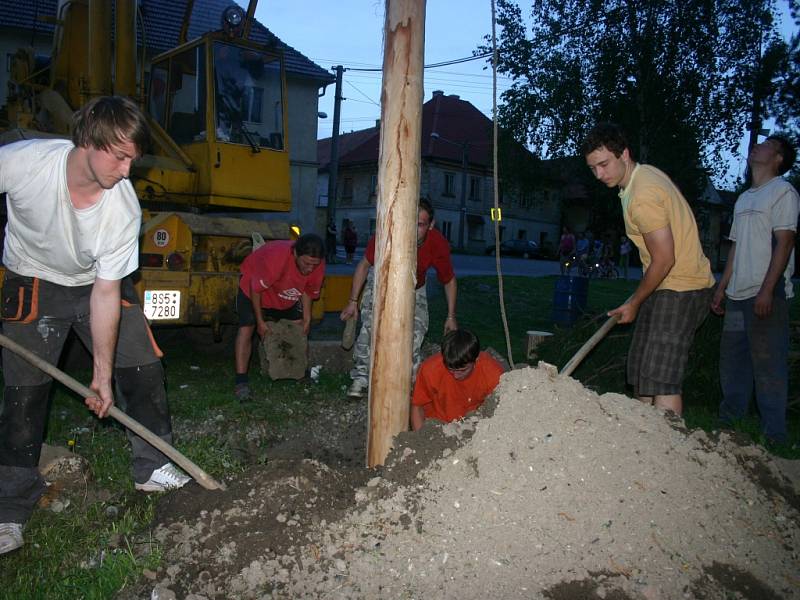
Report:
0,139,142,287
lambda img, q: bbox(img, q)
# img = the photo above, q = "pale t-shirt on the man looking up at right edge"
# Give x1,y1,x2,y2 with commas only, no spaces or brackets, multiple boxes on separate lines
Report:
725,177,800,300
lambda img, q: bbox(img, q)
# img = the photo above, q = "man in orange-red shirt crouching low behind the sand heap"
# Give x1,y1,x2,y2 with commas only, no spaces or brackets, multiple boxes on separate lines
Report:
411,329,503,431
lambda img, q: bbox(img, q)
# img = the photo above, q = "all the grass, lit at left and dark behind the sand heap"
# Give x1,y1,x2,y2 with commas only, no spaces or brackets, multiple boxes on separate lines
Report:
0,277,800,600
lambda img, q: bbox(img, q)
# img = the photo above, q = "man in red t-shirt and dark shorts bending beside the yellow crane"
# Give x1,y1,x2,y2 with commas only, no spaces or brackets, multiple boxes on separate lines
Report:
235,233,325,401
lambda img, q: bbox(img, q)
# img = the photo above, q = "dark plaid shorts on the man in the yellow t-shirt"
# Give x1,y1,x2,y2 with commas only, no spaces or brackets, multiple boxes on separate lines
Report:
628,288,712,396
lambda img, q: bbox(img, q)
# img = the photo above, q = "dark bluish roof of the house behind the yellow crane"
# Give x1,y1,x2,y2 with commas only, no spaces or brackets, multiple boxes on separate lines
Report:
0,0,335,84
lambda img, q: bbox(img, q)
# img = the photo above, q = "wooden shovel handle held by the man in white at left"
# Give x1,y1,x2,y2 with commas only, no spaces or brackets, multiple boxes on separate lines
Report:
0,334,226,490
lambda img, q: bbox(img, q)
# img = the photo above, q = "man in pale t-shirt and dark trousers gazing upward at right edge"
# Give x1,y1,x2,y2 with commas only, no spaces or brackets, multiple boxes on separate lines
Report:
711,136,800,443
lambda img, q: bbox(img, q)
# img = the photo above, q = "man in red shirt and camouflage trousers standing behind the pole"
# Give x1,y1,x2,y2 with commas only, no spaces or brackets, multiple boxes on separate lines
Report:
340,200,458,398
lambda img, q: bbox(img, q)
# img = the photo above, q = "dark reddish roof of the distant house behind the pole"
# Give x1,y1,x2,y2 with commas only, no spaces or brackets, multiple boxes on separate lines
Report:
317,91,492,168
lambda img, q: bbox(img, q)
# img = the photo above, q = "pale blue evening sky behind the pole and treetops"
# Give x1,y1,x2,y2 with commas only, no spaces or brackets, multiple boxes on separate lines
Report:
247,0,794,183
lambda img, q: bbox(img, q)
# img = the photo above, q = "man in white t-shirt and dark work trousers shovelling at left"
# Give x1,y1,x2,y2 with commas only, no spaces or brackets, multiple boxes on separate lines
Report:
0,97,189,554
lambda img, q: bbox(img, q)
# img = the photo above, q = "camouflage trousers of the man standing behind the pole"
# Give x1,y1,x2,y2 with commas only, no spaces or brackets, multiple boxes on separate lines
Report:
350,269,428,386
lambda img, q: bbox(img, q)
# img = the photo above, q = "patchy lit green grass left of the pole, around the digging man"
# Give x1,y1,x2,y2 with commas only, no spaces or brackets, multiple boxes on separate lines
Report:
0,340,349,600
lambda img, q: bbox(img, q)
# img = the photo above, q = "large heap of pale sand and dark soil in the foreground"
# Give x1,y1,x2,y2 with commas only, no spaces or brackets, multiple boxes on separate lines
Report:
128,367,800,600
